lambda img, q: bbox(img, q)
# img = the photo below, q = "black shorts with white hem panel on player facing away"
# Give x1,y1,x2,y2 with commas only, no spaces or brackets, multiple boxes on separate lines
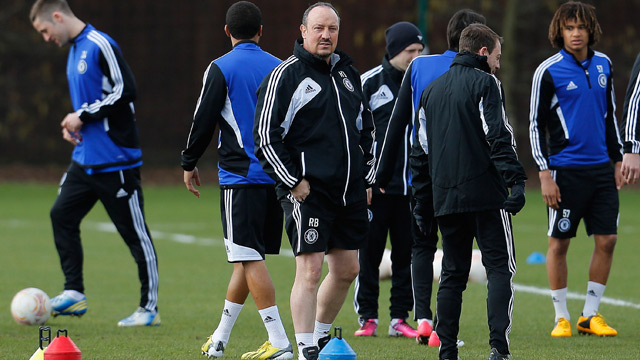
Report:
220,187,282,262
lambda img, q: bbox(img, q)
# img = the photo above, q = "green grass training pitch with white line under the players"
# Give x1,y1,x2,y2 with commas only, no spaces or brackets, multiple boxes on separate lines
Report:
0,183,640,360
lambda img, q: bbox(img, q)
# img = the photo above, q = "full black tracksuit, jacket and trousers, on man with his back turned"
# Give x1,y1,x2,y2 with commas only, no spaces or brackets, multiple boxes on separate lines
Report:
411,52,526,358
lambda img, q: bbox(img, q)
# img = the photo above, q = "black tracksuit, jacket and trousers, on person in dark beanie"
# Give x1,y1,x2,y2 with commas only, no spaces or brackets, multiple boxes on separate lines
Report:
354,55,413,320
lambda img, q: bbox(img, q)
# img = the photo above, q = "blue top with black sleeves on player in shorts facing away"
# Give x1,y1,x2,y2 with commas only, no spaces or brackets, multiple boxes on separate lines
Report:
182,41,281,187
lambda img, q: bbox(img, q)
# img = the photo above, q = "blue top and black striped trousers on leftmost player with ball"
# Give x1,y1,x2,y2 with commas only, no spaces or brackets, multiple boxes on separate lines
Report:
51,24,158,310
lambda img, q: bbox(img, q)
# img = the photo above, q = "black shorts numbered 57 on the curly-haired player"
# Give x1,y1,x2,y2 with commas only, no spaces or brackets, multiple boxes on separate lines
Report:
547,166,619,239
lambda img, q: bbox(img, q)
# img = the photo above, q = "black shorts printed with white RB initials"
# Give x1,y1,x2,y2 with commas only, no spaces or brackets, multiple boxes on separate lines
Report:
280,190,369,256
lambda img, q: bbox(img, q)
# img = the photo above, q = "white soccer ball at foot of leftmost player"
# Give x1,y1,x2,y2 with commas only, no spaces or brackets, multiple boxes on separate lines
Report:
11,288,51,325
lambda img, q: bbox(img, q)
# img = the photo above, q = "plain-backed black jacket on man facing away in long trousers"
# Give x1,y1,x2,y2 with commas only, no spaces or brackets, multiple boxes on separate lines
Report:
411,52,526,216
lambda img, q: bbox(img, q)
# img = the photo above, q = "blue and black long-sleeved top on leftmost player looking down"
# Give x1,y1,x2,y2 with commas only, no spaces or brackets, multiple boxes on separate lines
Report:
67,25,142,174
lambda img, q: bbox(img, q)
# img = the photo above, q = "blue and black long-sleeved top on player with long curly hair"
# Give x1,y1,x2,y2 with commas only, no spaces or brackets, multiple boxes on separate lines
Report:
529,49,622,171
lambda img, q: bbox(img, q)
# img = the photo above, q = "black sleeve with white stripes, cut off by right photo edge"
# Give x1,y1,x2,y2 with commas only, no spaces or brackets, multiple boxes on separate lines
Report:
620,54,640,154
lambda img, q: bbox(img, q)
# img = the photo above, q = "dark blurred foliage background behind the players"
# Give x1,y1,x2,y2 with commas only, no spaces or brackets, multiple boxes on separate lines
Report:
0,0,640,175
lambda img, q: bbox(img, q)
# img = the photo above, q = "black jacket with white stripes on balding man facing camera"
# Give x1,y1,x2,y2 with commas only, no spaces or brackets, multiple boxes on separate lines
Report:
253,39,375,206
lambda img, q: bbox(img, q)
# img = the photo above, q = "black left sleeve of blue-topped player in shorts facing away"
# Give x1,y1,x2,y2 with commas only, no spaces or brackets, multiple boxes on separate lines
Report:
181,62,227,171
